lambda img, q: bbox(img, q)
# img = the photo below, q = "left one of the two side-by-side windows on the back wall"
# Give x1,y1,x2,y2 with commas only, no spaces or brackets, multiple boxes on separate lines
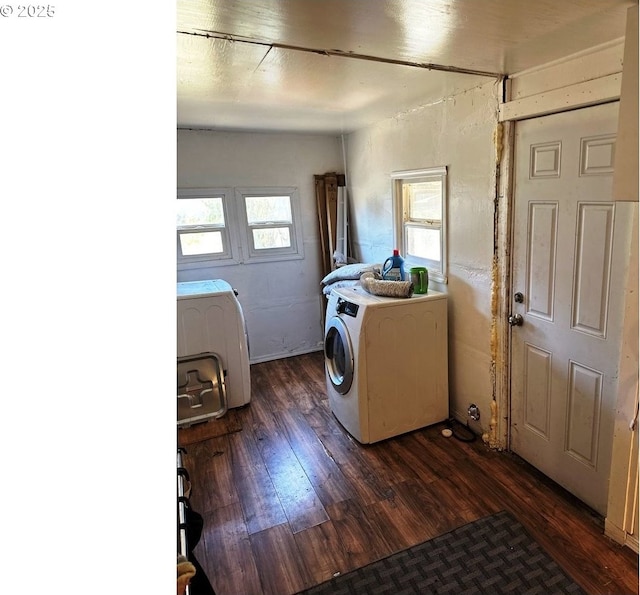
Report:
176,188,233,265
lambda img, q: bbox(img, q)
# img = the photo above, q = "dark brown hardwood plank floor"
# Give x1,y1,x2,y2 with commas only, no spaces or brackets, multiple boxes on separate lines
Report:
178,353,638,595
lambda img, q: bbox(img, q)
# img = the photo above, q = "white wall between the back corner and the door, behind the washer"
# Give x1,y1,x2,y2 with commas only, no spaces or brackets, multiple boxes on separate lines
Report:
346,82,499,430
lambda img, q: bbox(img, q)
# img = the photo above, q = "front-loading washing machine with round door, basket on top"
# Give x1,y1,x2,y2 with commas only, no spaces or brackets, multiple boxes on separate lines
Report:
324,286,449,444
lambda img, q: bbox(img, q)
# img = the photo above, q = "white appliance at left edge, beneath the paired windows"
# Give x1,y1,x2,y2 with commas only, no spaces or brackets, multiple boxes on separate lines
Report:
177,279,251,409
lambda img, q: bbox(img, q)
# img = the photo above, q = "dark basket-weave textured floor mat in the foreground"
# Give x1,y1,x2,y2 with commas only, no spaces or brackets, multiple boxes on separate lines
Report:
302,511,585,595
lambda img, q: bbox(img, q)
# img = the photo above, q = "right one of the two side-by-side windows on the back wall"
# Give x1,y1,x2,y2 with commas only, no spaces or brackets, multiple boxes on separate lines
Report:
235,187,302,262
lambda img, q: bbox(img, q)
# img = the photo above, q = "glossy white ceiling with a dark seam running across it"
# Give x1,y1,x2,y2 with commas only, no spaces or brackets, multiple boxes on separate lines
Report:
176,0,637,134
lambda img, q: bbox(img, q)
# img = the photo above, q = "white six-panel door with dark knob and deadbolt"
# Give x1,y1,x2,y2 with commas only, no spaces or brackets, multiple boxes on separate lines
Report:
510,103,630,515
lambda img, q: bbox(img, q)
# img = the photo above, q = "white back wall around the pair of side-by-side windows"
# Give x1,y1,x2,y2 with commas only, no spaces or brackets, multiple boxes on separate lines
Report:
177,130,343,363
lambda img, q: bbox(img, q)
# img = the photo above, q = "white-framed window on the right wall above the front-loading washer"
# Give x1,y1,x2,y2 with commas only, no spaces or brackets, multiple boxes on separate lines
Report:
391,167,447,283
